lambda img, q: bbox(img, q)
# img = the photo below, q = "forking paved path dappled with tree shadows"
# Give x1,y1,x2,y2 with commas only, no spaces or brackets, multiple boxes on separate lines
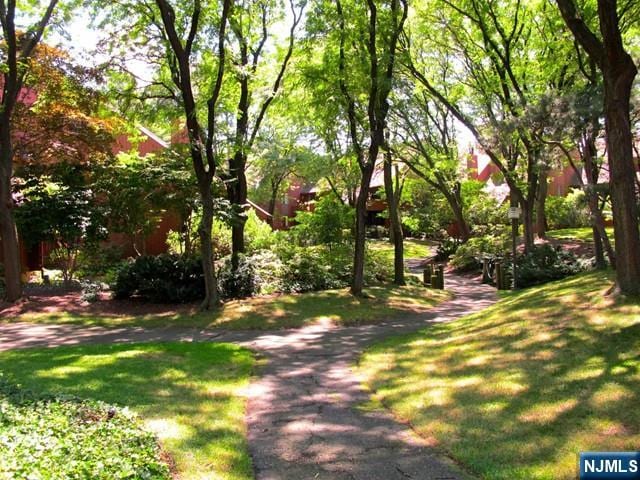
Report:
0,275,496,480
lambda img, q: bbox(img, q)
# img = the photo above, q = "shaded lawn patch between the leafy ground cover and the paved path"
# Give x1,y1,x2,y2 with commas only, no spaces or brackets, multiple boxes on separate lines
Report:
0,343,254,480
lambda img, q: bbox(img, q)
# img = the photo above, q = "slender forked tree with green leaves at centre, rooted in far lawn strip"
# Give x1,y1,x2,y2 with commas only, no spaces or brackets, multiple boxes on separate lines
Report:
325,0,408,296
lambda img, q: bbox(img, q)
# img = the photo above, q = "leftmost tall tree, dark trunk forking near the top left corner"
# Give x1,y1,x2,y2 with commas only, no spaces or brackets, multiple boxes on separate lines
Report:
0,0,59,302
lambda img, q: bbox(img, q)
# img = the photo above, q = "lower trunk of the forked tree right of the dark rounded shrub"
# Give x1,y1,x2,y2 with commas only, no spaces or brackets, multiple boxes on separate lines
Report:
198,182,222,310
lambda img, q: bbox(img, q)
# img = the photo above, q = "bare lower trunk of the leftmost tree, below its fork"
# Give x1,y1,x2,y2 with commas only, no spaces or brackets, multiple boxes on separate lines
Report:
0,125,22,302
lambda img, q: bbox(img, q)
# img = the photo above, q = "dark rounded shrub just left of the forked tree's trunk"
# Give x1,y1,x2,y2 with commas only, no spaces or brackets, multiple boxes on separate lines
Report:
113,254,205,303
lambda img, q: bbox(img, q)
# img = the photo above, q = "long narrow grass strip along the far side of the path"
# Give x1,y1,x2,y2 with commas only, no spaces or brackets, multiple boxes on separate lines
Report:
10,286,449,330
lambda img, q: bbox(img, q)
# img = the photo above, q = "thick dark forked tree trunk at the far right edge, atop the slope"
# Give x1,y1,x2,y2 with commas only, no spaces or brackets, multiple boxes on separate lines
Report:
556,0,640,295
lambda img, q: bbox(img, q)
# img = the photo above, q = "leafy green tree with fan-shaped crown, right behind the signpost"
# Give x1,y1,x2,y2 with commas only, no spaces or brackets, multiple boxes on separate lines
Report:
406,0,558,250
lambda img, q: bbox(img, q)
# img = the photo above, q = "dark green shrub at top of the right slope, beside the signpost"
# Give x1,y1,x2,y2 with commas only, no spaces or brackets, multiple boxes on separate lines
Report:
517,244,586,288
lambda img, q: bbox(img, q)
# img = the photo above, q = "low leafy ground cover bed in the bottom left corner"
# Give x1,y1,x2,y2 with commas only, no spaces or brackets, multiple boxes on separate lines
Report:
0,376,171,480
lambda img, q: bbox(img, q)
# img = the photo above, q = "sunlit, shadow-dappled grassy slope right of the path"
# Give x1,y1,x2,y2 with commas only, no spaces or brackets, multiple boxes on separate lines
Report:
361,272,640,480
